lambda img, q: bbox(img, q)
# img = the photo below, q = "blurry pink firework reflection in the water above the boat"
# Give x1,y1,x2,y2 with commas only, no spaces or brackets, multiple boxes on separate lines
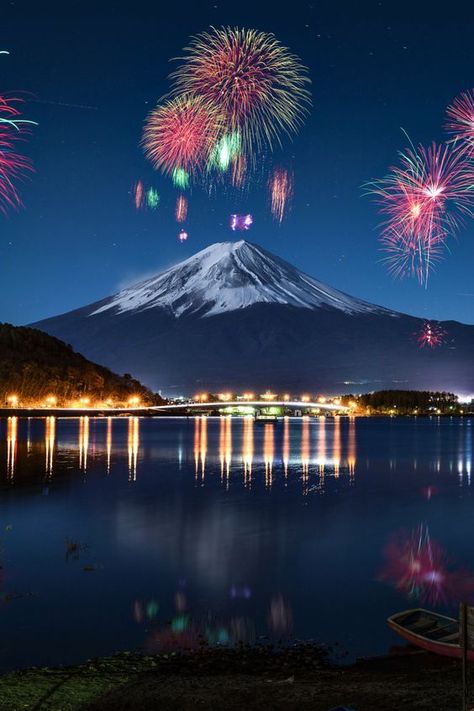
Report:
380,524,474,605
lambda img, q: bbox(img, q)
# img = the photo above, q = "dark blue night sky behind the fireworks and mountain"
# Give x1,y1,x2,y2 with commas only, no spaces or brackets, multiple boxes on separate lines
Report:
0,0,474,324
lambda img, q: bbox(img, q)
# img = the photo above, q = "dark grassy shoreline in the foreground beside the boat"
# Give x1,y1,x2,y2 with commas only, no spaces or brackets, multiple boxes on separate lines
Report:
0,644,461,711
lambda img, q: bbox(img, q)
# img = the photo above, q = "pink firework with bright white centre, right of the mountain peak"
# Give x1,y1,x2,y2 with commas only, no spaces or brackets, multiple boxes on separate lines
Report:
365,143,474,286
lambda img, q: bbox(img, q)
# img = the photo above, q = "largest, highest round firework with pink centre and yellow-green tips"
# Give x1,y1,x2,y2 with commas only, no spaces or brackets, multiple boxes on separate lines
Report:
171,27,311,158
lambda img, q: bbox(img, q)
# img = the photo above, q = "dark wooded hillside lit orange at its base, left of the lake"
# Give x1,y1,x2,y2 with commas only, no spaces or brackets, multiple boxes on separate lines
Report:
0,323,159,406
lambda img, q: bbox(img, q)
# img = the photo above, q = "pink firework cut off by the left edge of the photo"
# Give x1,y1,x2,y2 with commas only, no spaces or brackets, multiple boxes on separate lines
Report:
0,96,33,213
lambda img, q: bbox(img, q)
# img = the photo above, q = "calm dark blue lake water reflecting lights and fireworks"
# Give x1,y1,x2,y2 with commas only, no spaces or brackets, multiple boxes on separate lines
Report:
0,417,474,669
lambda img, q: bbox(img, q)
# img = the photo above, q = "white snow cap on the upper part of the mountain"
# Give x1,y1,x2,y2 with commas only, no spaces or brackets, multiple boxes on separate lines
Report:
89,240,395,318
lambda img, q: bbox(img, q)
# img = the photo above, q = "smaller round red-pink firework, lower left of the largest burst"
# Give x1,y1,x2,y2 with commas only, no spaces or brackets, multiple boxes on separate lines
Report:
142,95,222,181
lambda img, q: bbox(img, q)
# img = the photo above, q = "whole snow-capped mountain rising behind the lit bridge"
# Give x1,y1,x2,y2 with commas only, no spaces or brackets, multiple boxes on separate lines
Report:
35,240,474,394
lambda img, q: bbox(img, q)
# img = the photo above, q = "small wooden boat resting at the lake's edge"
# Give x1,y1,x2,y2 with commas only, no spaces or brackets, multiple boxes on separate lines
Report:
387,608,474,661
